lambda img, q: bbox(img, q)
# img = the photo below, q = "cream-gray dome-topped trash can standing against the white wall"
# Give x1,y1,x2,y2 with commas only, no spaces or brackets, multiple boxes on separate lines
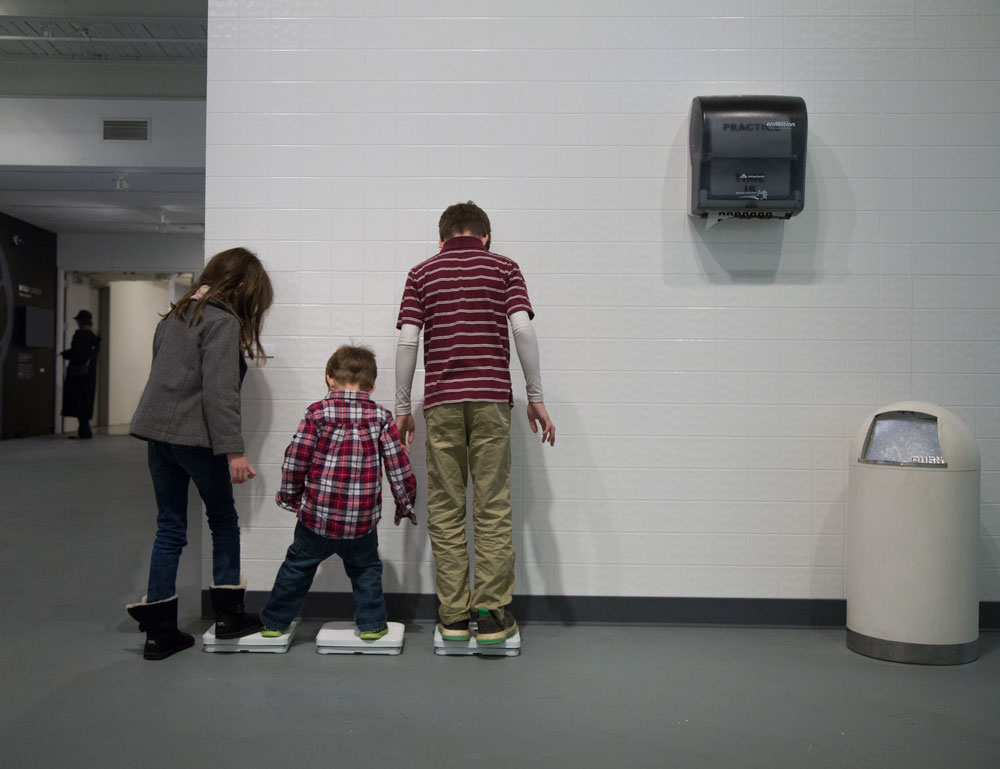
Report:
847,401,980,665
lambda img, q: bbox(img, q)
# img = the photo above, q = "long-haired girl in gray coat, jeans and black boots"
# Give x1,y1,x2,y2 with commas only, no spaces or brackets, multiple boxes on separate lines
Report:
127,248,274,660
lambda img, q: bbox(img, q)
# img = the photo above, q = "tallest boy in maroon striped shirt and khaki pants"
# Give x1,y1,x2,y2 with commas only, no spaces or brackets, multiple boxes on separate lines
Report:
396,201,555,644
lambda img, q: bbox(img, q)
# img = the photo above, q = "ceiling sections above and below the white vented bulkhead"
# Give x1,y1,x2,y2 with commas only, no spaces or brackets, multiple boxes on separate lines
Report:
0,0,208,233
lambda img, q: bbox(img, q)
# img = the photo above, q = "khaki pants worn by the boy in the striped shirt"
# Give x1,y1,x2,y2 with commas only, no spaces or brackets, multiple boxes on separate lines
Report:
424,402,514,623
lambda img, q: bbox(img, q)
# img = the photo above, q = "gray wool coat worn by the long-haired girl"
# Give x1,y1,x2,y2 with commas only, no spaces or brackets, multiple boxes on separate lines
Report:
129,299,246,454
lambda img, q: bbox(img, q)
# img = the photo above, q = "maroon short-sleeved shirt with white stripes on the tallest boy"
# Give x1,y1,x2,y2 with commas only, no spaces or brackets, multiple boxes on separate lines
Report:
396,236,535,409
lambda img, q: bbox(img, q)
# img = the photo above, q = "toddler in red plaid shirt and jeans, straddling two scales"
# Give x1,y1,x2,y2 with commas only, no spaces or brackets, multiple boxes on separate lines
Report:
260,345,417,641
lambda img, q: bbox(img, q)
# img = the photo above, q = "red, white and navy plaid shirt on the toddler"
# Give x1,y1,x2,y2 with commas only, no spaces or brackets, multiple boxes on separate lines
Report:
275,390,417,539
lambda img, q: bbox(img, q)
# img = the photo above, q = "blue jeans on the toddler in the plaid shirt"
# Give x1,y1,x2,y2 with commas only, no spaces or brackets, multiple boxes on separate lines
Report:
260,521,386,633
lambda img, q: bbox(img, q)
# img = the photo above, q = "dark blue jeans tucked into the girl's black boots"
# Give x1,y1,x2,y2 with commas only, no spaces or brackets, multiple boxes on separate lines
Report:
146,441,240,603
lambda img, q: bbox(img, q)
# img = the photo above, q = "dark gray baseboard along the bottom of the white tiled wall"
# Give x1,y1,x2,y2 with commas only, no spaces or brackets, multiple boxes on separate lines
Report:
201,590,1000,630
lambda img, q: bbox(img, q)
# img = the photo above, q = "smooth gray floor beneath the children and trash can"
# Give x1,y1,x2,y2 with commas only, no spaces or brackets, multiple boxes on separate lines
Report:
0,437,1000,769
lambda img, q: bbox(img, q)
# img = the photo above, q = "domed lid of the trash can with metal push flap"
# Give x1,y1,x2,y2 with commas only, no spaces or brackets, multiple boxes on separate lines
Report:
850,401,980,471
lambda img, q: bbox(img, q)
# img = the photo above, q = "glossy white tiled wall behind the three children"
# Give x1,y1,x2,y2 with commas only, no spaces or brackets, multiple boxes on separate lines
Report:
204,0,1000,600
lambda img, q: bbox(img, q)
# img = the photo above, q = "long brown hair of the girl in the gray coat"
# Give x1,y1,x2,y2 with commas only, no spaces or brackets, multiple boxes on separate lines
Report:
167,248,274,366
